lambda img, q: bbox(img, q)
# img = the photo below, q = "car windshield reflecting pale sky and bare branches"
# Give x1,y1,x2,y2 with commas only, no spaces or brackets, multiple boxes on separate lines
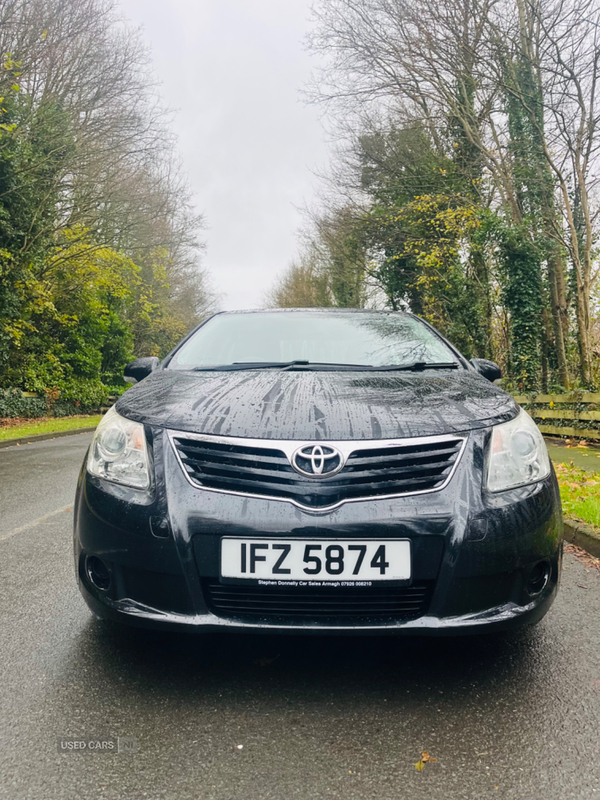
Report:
169,311,456,369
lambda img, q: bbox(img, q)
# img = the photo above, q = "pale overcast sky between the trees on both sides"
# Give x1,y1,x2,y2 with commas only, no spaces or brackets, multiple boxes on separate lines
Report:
121,0,327,309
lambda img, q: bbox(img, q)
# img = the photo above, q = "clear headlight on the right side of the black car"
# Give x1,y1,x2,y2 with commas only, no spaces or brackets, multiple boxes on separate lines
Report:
487,410,550,492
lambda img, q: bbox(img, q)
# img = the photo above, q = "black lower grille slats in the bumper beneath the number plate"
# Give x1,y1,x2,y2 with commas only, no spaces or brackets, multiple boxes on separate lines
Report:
202,580,433,624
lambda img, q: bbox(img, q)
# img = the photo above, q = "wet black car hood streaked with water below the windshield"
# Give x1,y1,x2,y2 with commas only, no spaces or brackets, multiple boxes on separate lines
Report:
116,370,518,441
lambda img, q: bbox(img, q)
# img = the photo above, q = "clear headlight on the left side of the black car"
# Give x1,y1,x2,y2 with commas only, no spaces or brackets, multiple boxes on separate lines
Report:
87,408,150,489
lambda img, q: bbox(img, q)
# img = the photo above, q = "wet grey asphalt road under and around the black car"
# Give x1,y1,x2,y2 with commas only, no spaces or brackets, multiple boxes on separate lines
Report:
0,434,600,800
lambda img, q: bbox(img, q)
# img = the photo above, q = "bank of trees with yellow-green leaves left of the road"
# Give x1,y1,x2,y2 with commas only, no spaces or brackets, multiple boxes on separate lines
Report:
0,0,214,398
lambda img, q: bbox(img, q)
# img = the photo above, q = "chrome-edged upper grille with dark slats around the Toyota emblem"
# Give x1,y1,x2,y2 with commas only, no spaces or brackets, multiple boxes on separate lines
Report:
172,433,464,511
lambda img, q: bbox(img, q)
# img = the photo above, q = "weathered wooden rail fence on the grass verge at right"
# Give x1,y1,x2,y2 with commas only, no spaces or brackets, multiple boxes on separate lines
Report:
514,392,600,440
